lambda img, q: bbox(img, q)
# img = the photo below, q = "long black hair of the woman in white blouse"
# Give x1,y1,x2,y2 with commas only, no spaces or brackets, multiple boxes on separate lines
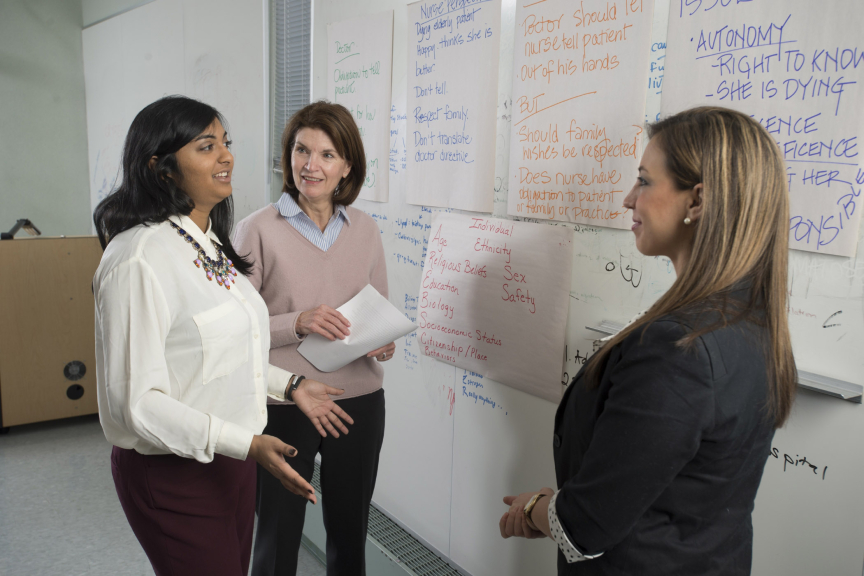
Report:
93,96,252,275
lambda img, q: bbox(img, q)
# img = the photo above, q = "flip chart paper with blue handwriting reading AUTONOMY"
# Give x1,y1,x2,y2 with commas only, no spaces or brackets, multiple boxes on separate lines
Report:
662,0,864,256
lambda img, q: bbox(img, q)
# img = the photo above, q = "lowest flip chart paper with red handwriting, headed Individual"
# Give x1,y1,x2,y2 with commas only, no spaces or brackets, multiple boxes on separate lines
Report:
417,213,573,402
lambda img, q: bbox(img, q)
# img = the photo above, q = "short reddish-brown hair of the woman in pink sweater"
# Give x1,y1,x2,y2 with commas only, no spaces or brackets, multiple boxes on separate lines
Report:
282,100,366,206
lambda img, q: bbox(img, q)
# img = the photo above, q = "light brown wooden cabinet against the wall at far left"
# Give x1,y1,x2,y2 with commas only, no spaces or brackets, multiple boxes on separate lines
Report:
0,236,102,427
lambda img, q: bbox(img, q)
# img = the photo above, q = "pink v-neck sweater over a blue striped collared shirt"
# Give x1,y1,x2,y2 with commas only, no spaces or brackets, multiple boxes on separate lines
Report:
233,205,387,404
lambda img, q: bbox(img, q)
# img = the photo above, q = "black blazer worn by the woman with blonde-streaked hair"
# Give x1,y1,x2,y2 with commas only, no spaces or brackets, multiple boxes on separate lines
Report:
553,317,774,576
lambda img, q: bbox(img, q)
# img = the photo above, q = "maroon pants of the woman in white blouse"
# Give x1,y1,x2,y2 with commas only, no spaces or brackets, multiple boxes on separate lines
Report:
111,446,255,576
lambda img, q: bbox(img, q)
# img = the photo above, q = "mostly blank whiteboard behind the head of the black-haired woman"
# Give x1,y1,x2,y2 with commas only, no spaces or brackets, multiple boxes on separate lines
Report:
81,0,269,227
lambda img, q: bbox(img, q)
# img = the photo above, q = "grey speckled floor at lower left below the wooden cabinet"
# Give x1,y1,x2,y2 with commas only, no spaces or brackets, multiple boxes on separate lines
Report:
0,416,326,576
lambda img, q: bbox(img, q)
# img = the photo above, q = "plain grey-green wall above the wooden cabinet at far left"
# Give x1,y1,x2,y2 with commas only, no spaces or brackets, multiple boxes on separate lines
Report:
0,0,90,235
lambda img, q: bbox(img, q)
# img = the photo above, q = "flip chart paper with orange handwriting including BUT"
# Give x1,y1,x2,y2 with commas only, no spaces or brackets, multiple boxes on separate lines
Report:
507,0,654,229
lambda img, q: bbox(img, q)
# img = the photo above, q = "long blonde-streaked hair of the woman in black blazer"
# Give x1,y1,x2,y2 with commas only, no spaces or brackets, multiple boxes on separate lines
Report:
586,107,797,428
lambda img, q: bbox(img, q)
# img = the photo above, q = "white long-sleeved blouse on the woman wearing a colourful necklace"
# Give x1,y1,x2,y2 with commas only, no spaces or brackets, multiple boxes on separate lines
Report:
93,216,291,462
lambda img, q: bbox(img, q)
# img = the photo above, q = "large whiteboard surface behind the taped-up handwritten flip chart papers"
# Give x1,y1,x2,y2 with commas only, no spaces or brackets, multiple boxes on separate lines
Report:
338,0,864,576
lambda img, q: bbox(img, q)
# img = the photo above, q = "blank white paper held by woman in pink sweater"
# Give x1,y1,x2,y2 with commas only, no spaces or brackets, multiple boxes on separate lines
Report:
297,284,417,372
